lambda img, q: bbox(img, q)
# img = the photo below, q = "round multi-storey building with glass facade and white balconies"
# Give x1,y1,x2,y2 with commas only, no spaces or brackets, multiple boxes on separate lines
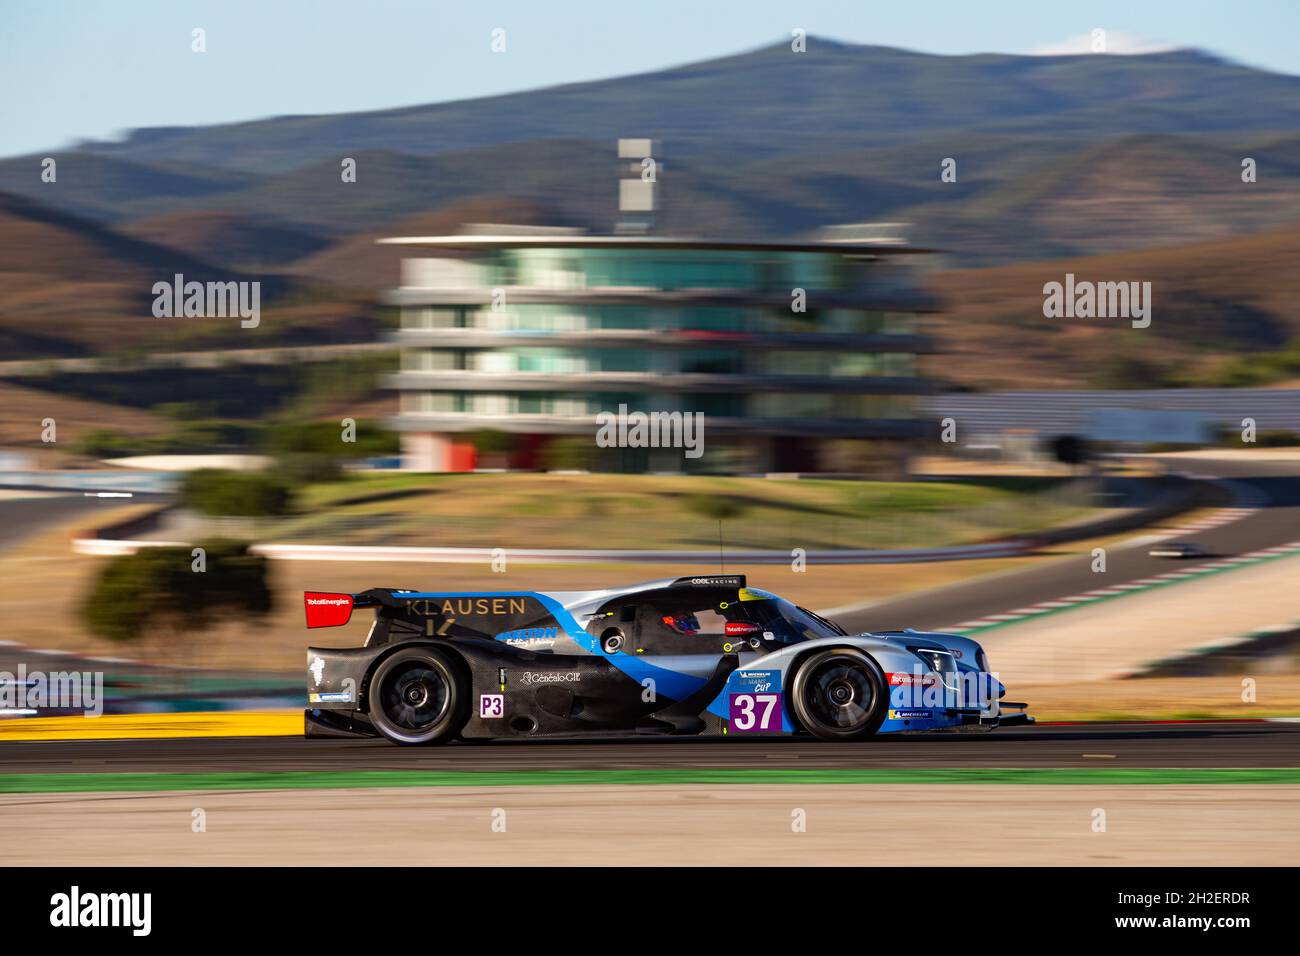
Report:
384,230,932,472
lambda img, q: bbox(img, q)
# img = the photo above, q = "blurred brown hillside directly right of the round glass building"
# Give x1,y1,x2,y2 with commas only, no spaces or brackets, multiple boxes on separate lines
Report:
931,224,1300,389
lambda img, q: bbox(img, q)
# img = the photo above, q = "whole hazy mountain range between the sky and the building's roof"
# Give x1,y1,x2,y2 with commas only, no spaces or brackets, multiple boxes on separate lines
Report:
0,38,1300,269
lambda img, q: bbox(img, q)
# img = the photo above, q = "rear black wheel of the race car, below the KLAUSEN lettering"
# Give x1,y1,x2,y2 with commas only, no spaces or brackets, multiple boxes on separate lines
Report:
368,648,469,745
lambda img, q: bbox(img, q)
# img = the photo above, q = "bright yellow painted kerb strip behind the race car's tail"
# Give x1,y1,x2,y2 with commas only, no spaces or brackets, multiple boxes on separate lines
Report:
0,710,303,740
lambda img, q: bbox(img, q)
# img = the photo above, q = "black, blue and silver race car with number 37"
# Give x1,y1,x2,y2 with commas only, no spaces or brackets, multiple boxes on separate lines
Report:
304,574,1032,744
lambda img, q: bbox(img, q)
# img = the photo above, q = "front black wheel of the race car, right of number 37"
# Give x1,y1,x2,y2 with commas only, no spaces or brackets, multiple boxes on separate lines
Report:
790,648,889,740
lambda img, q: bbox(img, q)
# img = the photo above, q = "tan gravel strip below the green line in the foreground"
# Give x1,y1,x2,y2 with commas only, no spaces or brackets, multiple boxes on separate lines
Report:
0,784,1300,871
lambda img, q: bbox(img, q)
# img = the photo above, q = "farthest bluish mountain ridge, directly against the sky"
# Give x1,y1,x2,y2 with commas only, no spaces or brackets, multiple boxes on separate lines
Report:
65,38,1300,173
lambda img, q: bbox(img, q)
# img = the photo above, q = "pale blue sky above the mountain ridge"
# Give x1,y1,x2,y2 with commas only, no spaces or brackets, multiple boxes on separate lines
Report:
0,0,1300,156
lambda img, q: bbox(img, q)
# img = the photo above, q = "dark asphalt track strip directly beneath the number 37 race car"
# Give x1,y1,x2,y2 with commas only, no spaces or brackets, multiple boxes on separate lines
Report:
0,722,1300,774
